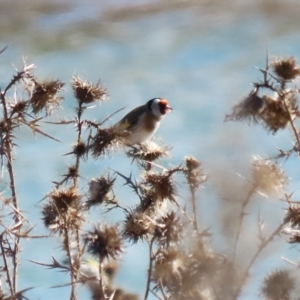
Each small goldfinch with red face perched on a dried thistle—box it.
[115,98,173,146]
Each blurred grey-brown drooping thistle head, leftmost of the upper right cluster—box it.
[225,88,264,122]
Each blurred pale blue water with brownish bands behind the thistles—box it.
[0,0,300,300]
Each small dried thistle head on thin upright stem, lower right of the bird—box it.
[184,156,207,190]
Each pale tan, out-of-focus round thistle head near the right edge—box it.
[252,156,288,195]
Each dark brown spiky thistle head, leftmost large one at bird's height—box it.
[30,80,64,114]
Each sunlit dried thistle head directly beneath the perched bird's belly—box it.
[127,141,170,164]
